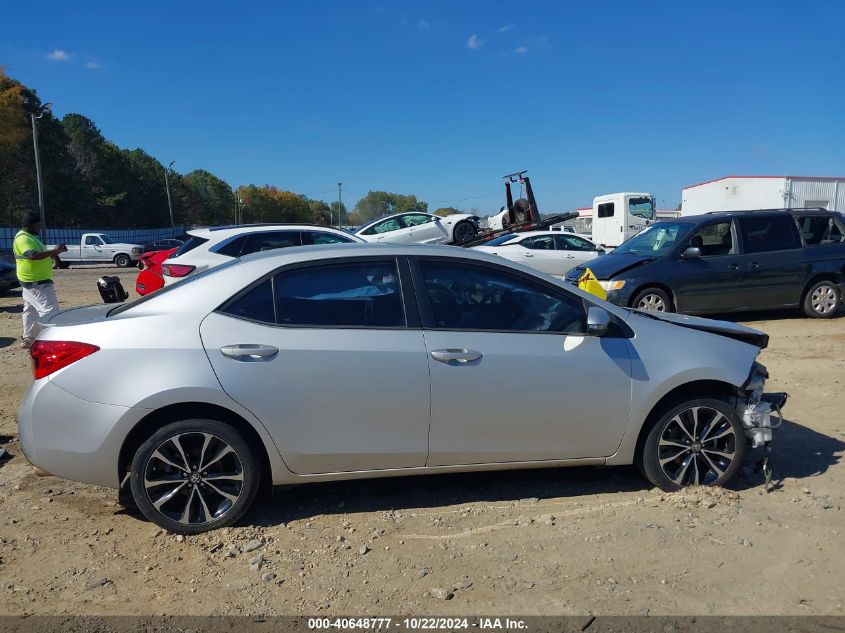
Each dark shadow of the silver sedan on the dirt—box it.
[245,420,845,526]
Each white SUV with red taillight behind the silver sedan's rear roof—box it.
[161,224,364,286]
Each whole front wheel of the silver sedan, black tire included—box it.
[637,398,746,492]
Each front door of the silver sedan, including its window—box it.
[414,258,631,466]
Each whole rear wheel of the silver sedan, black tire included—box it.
[130,420,261,534]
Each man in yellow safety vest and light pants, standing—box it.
[12,212,67,349]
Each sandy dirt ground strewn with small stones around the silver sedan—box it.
[0,268,845,616]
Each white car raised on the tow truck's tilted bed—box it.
[355,212,478,244]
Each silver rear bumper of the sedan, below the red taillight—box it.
[18,379,145,488]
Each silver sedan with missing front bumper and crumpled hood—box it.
[18,244,781,534]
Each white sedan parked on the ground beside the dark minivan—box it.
[474,231,604,277]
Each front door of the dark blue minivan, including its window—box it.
[659,218,747,313]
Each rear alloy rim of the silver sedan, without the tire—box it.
[144,432,244,525]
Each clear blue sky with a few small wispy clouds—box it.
[0,0,845,213]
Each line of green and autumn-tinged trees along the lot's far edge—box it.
[0,67,464,228]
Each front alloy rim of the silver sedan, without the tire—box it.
[657,406,737,486]
